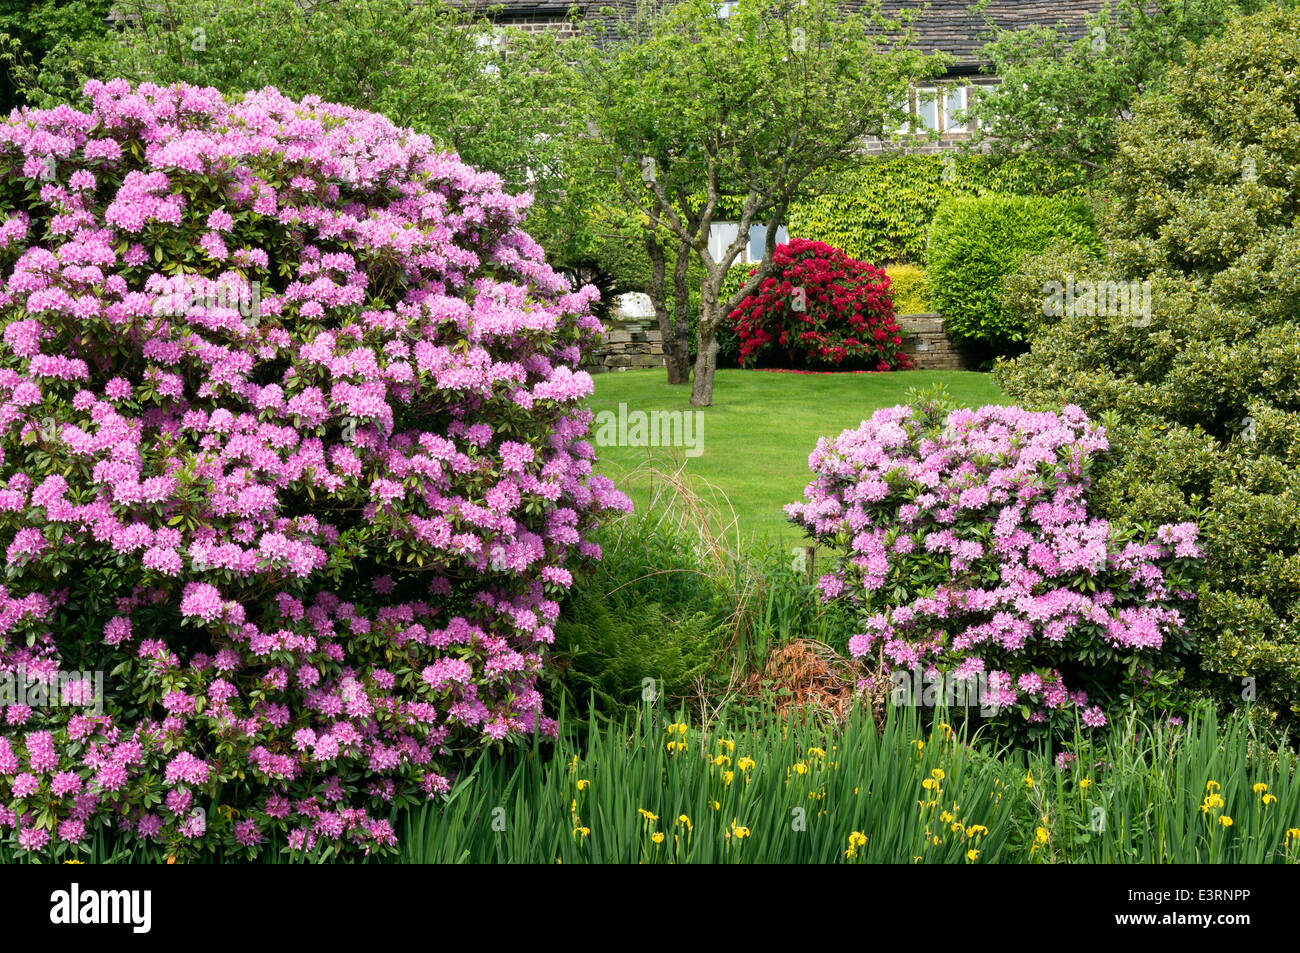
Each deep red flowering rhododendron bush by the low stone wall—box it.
[728,238,913,371]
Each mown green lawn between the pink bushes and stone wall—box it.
[589,369,1008,543]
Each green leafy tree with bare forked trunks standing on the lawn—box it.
[569,0,943,407]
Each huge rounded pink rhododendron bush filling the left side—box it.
[0,81,629,858]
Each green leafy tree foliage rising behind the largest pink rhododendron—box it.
[33,0,579,229]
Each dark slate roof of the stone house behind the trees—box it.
[493,0,1101,73]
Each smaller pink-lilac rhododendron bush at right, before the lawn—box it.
[785,403,1201,736]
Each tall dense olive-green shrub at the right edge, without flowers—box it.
[1000,3,1300,731]
